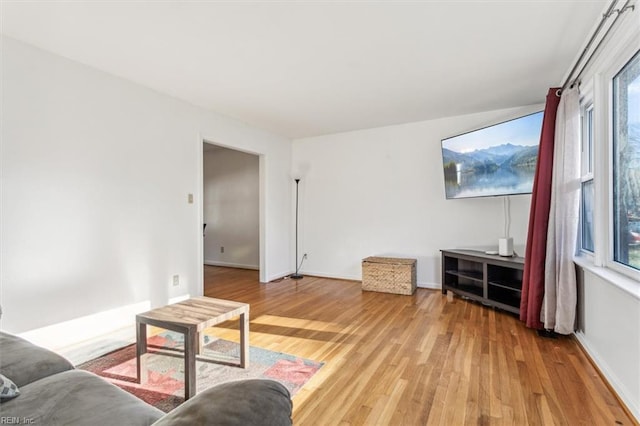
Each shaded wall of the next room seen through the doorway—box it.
[203,148,260,269]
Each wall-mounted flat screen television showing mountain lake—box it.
[442,111,543,199]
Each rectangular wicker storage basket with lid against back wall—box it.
[362,257,416,295]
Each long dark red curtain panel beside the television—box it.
[520,88,560,329]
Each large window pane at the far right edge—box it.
[612,52,640,269]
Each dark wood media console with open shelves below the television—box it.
[441,249,524,314]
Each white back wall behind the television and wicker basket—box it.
[292,105,544,287]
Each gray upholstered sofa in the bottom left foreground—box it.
[0,332,292,426]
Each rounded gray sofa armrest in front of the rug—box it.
[153,379,292,426]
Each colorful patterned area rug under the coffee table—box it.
[78,331,324,412]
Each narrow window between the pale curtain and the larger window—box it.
[580,105,594,253]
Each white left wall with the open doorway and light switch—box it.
[0,38,291,339]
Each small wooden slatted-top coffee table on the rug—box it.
[136,296,249,400]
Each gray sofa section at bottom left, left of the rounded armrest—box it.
[2,370,164,426]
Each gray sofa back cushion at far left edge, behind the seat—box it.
[0,331,73,388]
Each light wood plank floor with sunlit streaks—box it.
[205,266,637,425]
